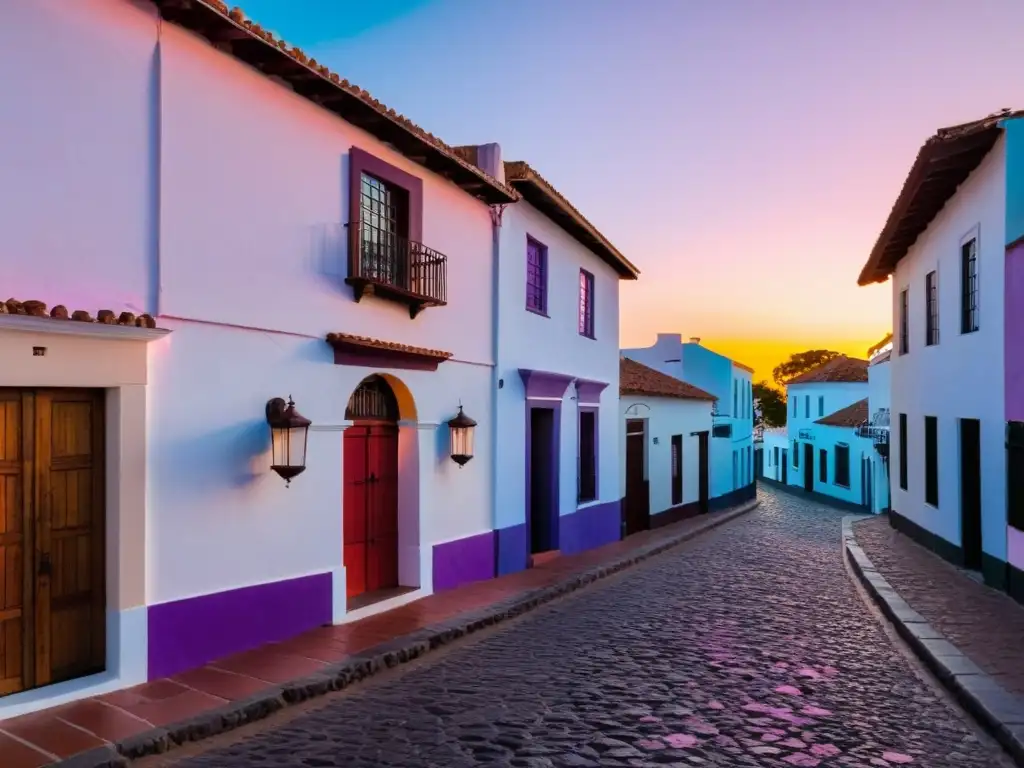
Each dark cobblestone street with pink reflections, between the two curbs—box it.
[163,490,1004,768]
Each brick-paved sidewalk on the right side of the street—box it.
[854,517,1024,694]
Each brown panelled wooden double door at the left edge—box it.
[0,389,106,694]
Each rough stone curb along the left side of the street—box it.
[56,499,761,768]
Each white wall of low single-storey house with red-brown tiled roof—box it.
[620,395,711,516]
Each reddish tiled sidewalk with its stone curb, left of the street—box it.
[0,501,758,768]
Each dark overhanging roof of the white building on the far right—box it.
[857,110,1024,286]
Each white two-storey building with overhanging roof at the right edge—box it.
[859,112,1024,599]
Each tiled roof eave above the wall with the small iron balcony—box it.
[153,0,519,205]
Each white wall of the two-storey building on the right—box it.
[890,138,1007,559]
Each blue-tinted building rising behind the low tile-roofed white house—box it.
[623,334,756,509]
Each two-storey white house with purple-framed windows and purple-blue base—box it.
[452,144,639,573]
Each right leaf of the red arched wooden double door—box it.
[367,424,398,592]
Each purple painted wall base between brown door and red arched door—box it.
[147,573,333,680]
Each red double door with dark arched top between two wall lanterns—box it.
[343,376,398,599]
